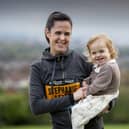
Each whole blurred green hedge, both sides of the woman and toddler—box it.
[0,86,129,125]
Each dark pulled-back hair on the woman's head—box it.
[45,11,72,43]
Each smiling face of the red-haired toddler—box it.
[90,39,111,66]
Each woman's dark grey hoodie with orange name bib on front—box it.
[30,48,104,129]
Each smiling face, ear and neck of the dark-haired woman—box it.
[45,21,72,55]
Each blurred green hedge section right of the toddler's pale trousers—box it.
[104,86,129,123]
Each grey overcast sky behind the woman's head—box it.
[0,0,129,44]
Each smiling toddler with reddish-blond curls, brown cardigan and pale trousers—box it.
[71,34,120,129]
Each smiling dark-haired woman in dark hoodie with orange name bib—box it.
[30,12,111,129]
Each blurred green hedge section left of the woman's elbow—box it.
[0,92,50,125]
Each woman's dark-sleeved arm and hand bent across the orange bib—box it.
[29,64,84,115]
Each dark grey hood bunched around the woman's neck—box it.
[41,47,72,60]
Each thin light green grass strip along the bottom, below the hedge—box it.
[0,124,129,129]
